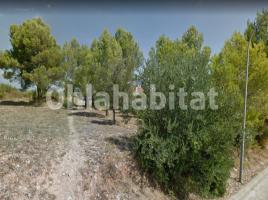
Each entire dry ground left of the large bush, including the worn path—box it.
[0,105,168,200]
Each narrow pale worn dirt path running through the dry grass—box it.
[43,112,85,200]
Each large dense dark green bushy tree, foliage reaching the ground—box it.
[135,27,238,199]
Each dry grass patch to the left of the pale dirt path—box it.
[0,106,68,199]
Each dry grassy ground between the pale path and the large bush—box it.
[67,111,168,200]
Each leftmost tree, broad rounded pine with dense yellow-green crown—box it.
[0,18,63,98]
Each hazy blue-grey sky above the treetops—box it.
[0,4,268,85]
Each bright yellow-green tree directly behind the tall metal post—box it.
[212,33,268,142]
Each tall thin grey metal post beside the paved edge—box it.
[239,31,254,183]
